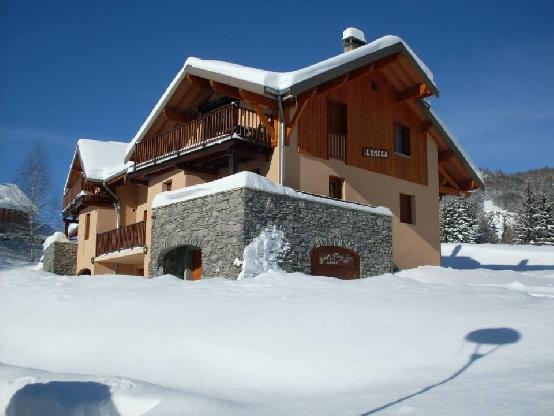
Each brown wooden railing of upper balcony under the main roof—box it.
[134,104,271,165]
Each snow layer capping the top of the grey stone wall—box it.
[152,172,392,215]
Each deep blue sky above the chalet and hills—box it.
[0,0,554,199]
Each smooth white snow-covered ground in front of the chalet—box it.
[0,245,554,416]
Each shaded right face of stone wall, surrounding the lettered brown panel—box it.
[245,189,392,277]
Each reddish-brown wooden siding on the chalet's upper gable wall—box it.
[298,72,427,185]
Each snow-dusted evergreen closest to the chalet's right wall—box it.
[441,197,477,243]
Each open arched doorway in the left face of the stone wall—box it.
[160,245,202,280]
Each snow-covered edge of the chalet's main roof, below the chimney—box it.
[125,35,438,161]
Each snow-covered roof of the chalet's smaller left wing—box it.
[65,139,133,187]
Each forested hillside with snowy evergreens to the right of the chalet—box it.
[441,167,554,245]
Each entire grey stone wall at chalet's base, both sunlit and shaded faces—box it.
[150,188,392,278]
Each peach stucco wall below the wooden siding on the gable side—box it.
[282,128,440,268]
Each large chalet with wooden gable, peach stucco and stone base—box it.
[63,28,483,279]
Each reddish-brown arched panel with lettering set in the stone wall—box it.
[311,246,360,280]
